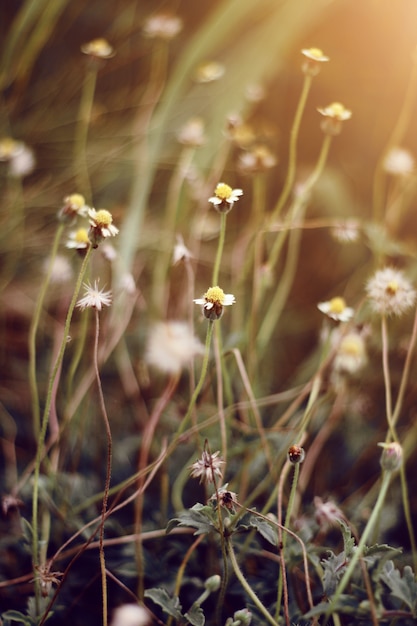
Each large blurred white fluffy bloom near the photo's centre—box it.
[145,321,204,374]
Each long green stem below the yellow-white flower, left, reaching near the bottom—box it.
[32,247,92,604]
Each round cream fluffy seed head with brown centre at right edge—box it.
[366,267,416,316]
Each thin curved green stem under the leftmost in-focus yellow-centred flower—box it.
[28,223,64,438]
